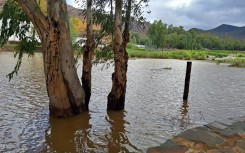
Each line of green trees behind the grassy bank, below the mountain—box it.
[131,20,245,50]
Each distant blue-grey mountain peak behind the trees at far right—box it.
[192,24,245,40]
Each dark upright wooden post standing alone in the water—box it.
[183,61,192,100]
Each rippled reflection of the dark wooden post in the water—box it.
[180,100,190,130]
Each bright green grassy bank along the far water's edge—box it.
[127,48,245,67]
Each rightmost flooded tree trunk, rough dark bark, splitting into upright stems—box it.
[107,0,131,110]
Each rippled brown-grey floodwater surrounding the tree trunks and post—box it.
[0,52,245,153]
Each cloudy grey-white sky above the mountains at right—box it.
[67,0,245,30]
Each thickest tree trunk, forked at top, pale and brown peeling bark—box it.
[17,0,85,117]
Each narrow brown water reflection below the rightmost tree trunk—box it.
[106,111,141,153]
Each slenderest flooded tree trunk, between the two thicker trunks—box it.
[82,0,95,110]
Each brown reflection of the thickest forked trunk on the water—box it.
[44,112,95,153]
